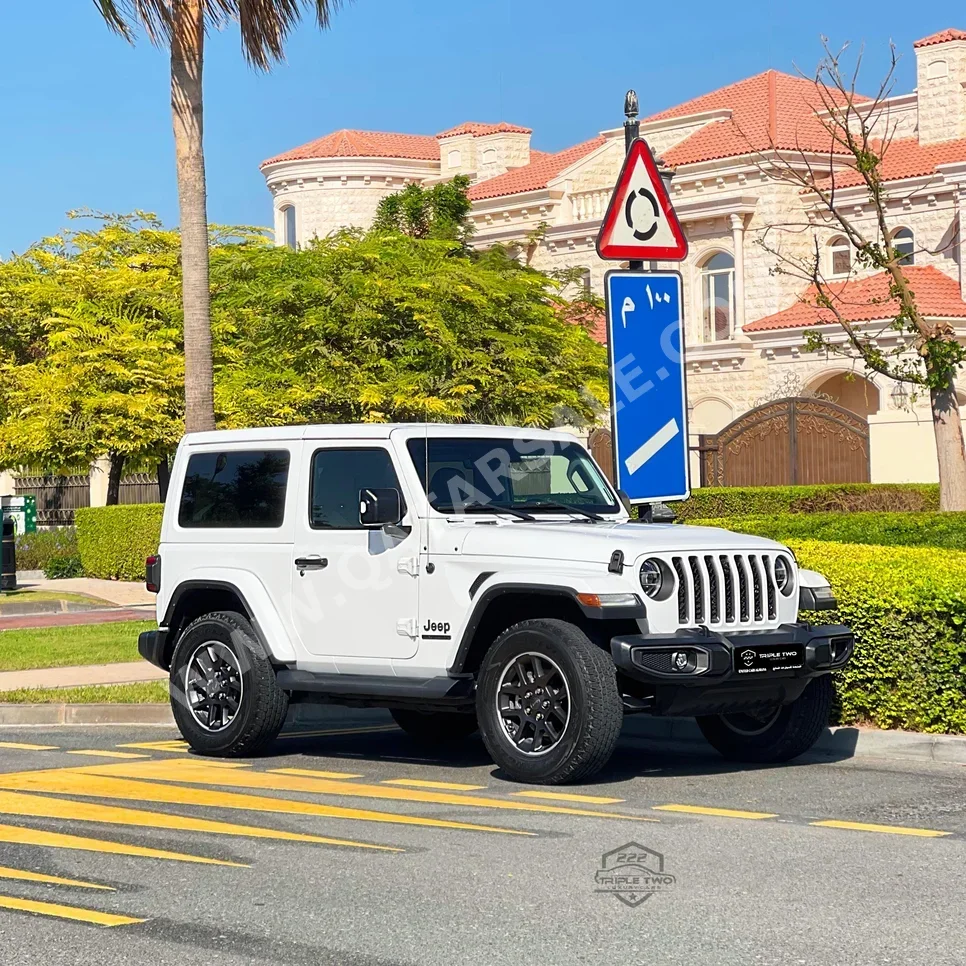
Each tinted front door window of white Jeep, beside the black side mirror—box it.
[309,448,405,530]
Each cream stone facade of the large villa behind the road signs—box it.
[263,31,966,480]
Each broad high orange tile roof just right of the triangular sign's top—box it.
[647,70,866,167]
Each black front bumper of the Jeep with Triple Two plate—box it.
[610,623,855,715]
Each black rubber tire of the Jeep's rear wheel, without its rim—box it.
[170,611,288,758]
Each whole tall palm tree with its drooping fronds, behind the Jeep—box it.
[94,0,341,433]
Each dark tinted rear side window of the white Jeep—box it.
[178,450,289,529]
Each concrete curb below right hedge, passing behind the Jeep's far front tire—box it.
[629,715,966,765]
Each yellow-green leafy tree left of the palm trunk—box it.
[0,211,184,502]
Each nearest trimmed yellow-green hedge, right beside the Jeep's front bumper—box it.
[790,540,966,734]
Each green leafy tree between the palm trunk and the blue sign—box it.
[212,229,607,426]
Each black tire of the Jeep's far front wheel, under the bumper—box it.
[697,674,832,764]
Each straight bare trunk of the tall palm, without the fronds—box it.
[171,0,215,433]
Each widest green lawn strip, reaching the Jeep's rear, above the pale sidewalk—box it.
[0,621,157,671]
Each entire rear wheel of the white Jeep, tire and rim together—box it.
[170,611,288,758]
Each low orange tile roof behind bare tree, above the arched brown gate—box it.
[744,265,966,332]
